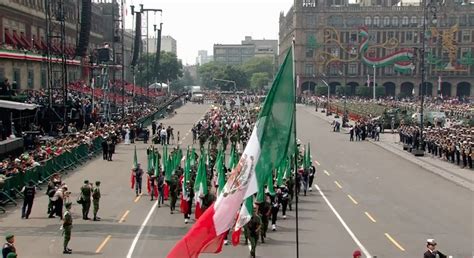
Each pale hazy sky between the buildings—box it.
[126,0,293,64]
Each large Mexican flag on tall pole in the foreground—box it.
[168,47,295,258]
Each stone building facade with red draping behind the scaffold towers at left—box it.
[0,0,108,90]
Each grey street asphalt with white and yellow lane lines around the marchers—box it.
[0,104,474,258]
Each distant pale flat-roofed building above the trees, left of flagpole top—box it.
[214,36,278,65]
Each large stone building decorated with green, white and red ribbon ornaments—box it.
[279,0,474,96]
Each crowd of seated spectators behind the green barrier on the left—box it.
[0,88,178,176]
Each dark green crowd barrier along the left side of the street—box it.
[0,137,103,211]
